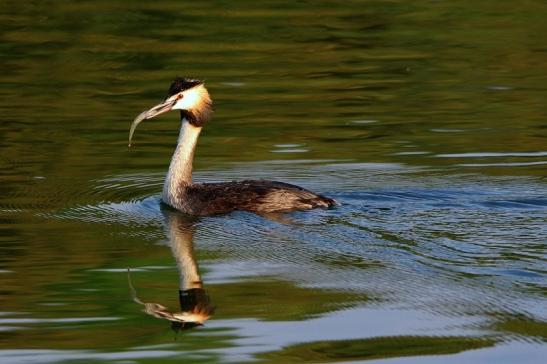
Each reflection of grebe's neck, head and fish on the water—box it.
[127,207,215,332]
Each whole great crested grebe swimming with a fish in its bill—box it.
[129,77,336,215]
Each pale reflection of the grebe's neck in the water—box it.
[169,218,202,291]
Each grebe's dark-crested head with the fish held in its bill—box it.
[129,77,213,146]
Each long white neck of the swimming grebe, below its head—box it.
[162,119,201,207]
